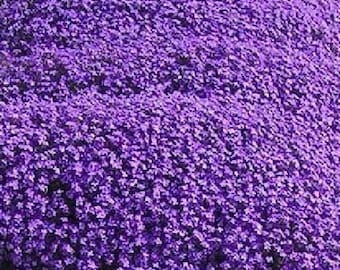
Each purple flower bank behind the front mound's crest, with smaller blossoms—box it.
[0,0,340,105]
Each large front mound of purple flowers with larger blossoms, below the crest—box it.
[0,94,339,269]
